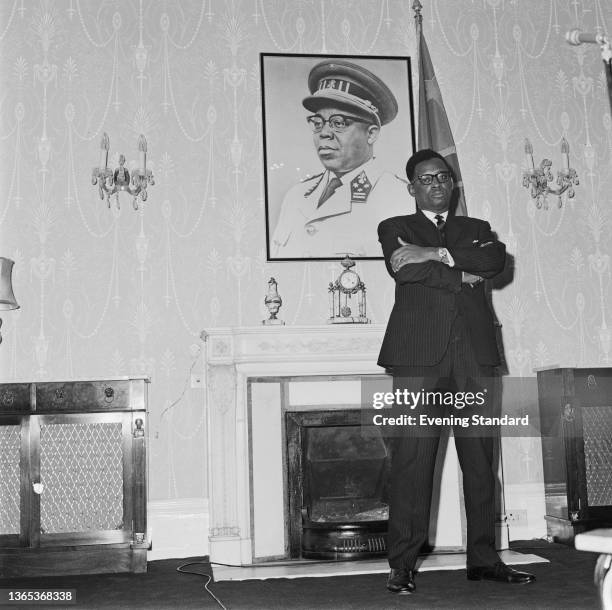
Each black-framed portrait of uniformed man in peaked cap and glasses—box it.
[260,53,416,261]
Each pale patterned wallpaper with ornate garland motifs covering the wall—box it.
[0,0,612,498]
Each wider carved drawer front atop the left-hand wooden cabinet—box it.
[36,380,130,413]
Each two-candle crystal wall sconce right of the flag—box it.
[523,138,580,210]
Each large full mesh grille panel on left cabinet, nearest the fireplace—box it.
[40,423,123,534]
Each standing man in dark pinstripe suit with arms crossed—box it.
[378,149,534,594]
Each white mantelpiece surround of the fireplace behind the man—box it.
[206,325,463,565]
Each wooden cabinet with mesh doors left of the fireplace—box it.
[0,378,149,578]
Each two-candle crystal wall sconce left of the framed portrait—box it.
[91,132,155,210]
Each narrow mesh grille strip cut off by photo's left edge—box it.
[0,426,21,534]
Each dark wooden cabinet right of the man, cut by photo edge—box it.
[538,368,612,543]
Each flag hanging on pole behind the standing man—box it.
[413,0,467,216]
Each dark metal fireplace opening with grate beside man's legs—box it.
[286,409,390,560]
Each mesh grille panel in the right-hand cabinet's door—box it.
[582,407,612,506]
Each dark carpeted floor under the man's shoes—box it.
[0,540,598,610]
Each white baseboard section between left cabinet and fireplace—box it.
[147,498,209,561]
